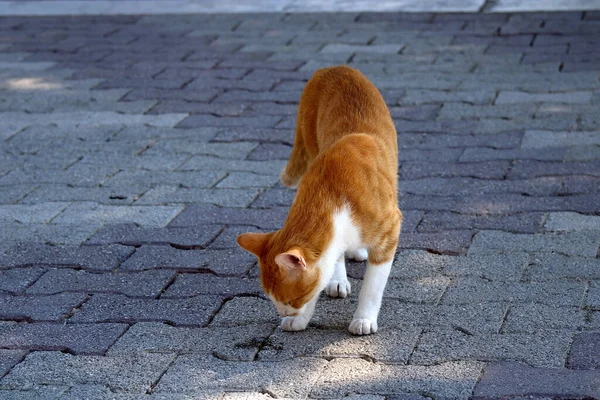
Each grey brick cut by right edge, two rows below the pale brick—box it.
[525,253,600,281]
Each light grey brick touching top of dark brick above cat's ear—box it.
[136,185,259,208]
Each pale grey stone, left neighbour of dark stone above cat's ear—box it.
[53,203,183,226]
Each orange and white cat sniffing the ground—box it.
[238,66,402,335]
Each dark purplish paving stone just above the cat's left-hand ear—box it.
[169,204,289,229]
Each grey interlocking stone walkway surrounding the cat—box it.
[0,7,600,400]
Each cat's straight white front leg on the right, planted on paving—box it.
[348,259,393,335]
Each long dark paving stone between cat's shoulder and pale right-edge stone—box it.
[418,211,545,233]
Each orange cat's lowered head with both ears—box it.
[237,232,321,316]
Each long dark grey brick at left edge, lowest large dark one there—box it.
[0,322,127,355]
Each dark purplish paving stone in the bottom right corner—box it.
[474,362,600,399]
